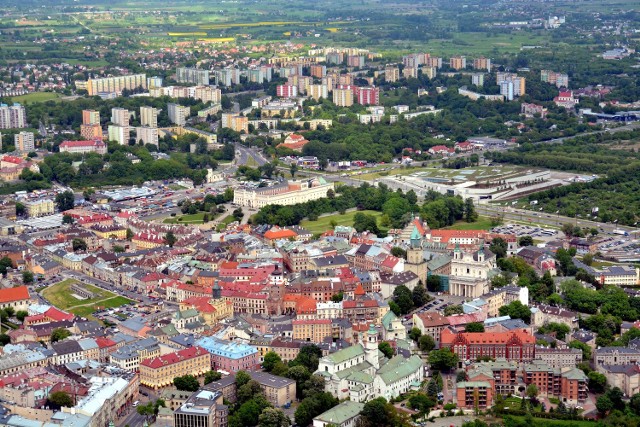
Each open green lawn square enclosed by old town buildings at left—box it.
[42,279,131,318]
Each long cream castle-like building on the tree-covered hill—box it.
[233,177,334,209]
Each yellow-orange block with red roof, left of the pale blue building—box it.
[140,346,211,390]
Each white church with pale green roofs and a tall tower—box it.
[315,325,424,402]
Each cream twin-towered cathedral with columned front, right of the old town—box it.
[449,244,497,298]
